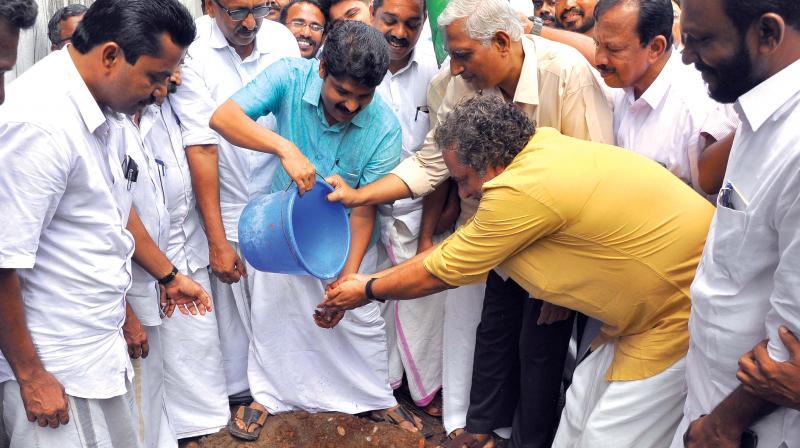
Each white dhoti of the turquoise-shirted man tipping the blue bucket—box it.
[248,248,396,414]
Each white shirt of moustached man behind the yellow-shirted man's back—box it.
[614,51,739,188]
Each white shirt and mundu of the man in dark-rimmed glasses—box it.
[170,18,300,395]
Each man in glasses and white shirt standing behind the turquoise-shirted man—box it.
[170,0,306,402]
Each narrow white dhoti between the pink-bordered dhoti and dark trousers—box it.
[442,283,486,434]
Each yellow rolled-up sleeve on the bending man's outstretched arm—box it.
[424,186,564,286]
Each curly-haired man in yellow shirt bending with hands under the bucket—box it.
[322,95,714,448]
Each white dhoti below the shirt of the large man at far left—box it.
[0,381,142,448]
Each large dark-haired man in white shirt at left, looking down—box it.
[0,0,210,448]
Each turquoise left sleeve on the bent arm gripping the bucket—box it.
[231,58,290,120]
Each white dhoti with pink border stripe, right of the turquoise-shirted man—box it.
[378,205,447,406]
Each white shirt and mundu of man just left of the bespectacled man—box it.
[140,101,230,439]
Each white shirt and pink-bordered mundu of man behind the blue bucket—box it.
[377,42,447,406]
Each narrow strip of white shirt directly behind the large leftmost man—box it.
[126,114,170,327]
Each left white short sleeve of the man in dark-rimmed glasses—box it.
[169,49,219,147]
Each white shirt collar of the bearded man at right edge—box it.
[735,60,800,132]
